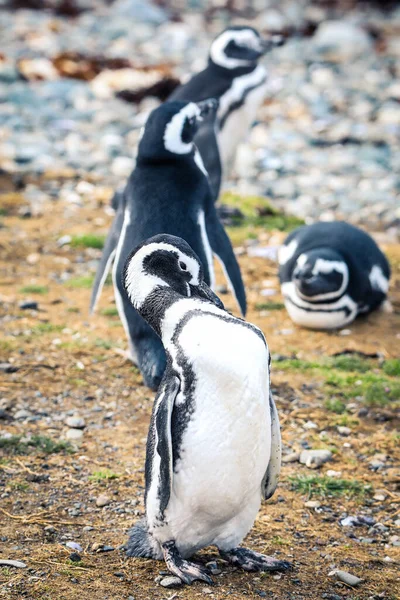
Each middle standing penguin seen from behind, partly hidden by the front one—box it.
[91,100,246,389]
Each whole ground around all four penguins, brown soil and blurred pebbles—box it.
[0,0,400,600]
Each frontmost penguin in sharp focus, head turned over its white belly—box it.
[123,235,290,584]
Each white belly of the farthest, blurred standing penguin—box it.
[218,83,268,167]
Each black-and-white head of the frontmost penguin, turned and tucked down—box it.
[123,234,224,312]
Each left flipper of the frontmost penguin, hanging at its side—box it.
[146,372,180,527]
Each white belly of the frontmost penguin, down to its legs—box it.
[166,314,271,556]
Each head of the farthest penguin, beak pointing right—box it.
[210,26,283,70]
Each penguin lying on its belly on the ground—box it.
[278,221,390,329]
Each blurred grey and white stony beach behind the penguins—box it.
[0,0,400,232]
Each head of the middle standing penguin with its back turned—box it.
[138,98,218,162]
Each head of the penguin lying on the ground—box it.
[292,248,349,302]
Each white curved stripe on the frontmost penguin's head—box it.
[125,242,200,308]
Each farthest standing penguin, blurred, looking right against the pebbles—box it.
[169,25,283,200]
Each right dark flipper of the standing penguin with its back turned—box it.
[206,206,247,317]
